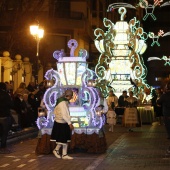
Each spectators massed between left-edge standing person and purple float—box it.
[5,82,46,131]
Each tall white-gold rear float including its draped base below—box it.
[94,3,157,126]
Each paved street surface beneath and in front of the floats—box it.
[0,123,170,170]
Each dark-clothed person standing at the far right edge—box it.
[157,81,170,154]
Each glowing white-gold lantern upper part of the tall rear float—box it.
[94,4,150,96]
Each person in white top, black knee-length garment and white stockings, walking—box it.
[51,90,74,159]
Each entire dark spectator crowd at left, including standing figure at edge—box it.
[0,82,46,154]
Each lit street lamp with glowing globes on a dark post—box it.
[30,24,44,84]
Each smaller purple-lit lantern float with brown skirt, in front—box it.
[37,39,106,153]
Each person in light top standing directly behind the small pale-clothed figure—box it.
[107,90,118,110]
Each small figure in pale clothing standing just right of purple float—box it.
[106,110,116,132]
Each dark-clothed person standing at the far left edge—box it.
[0,82,13,154]
